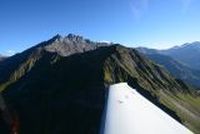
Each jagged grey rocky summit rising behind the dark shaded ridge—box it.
[33,33,110,56]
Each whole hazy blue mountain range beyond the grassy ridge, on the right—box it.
[137,42,200,88]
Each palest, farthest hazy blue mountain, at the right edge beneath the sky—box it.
[160,42,200,70]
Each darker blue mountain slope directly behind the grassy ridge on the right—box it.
[137,46,200,88]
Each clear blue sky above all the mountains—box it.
[0,0,200,55]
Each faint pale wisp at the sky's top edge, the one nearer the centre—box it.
[131,0,150,19]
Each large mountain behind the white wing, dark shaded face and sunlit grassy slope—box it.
[0,35,200,134]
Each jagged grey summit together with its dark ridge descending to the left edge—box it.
[0,34,110,83]
